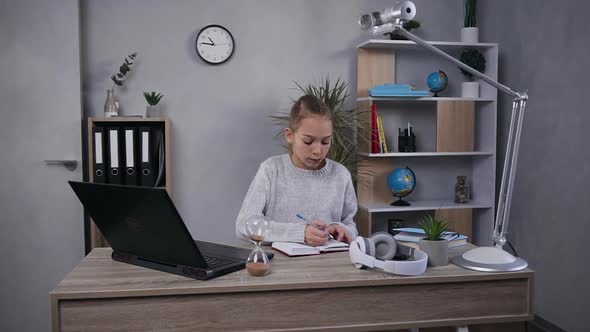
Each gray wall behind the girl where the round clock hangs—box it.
[82,0,462,243]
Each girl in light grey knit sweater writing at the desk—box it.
[236,95,358,246]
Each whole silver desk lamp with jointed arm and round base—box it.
[358,1,528,272]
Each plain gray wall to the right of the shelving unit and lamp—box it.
[479,0,590,331]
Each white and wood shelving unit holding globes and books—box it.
[357,39,498,245]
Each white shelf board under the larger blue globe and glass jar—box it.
[359,197,492,213]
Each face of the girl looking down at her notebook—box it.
[285,114,332,170]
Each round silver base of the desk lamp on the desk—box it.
[451,247,528,272]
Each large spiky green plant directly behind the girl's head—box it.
[271,76,370,178]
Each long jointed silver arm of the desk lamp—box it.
[394,24,528,249]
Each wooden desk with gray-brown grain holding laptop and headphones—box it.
[51,245,534,331]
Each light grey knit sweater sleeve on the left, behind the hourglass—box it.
[236,163,305,243]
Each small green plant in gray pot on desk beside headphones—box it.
[418,215,449,266]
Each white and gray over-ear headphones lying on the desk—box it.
[348,232,428,276]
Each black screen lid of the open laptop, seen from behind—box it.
[69,181,206,267]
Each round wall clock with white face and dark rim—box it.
[195,25,235,65]
